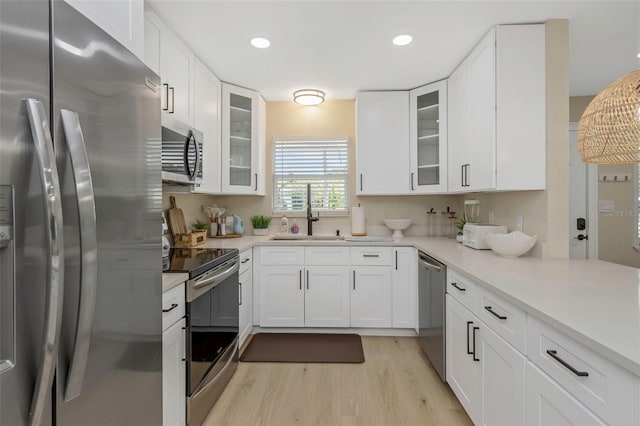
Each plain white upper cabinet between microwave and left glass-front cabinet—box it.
[194,60,222,194]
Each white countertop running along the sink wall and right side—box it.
[163,236,640,376]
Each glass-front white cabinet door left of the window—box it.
[222,83,259,194]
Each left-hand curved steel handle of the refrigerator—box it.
[26,98,64,425]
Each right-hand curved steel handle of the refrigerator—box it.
[60,109,98,401]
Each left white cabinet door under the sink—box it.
[259,266,304,327]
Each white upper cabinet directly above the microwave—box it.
[144,12,196,126]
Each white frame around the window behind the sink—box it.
[271,135,351,217]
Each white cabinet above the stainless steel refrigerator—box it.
[65,0,145,59]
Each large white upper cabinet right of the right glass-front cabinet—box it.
[448,24,546,192]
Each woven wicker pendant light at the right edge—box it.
[578,70,640,164]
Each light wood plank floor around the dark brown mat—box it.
[204,336,472,426]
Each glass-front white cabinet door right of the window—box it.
[409,80,447,194]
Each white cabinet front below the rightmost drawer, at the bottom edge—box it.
[526,362,606,426]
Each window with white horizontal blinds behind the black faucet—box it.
[273,138,349,216]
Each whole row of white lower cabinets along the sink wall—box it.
[253,245,418,329]
